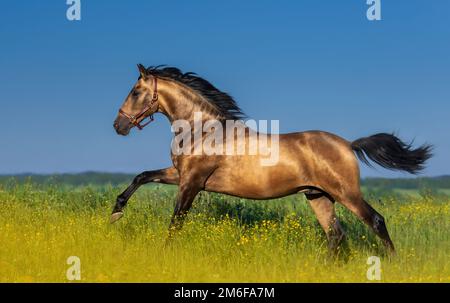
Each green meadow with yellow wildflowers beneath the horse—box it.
[0,178,450,282]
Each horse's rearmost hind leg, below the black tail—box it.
[340,197,395,253]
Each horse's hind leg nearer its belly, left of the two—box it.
[306,193,345,255]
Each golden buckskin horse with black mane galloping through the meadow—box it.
[111,64,431,252]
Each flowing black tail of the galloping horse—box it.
[352,134,432,174]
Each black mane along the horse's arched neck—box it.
[147,66,245,120]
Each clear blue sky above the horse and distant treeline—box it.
[0,0,450,177]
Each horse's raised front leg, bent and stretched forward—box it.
[110,167,179,223]
